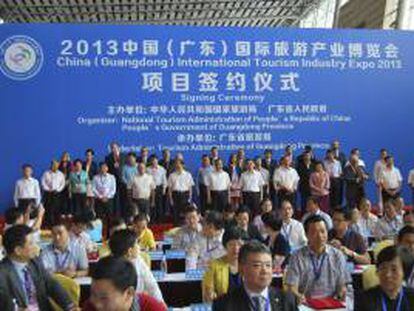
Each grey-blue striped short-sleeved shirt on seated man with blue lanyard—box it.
[286,245,351,297]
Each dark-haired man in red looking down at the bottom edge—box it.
[82,256,167,311]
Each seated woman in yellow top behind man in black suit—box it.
[202,227,246,303]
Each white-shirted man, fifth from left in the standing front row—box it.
[129,162,155,215]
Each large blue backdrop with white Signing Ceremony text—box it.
[0,24,414,214]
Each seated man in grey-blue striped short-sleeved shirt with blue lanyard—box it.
[286,215,350,303]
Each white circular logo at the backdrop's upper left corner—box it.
[0,36,43,80]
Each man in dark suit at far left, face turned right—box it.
[0,225,80,311]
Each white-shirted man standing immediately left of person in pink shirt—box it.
[273,156,299,211]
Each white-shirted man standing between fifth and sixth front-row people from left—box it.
[147,155,167,221]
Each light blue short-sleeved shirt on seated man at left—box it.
[41,240,89,273]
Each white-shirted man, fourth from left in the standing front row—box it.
[92,162,116,228]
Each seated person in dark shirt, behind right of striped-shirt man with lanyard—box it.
[328,208,371,265]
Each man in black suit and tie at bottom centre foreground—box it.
[213,241,298,311]
